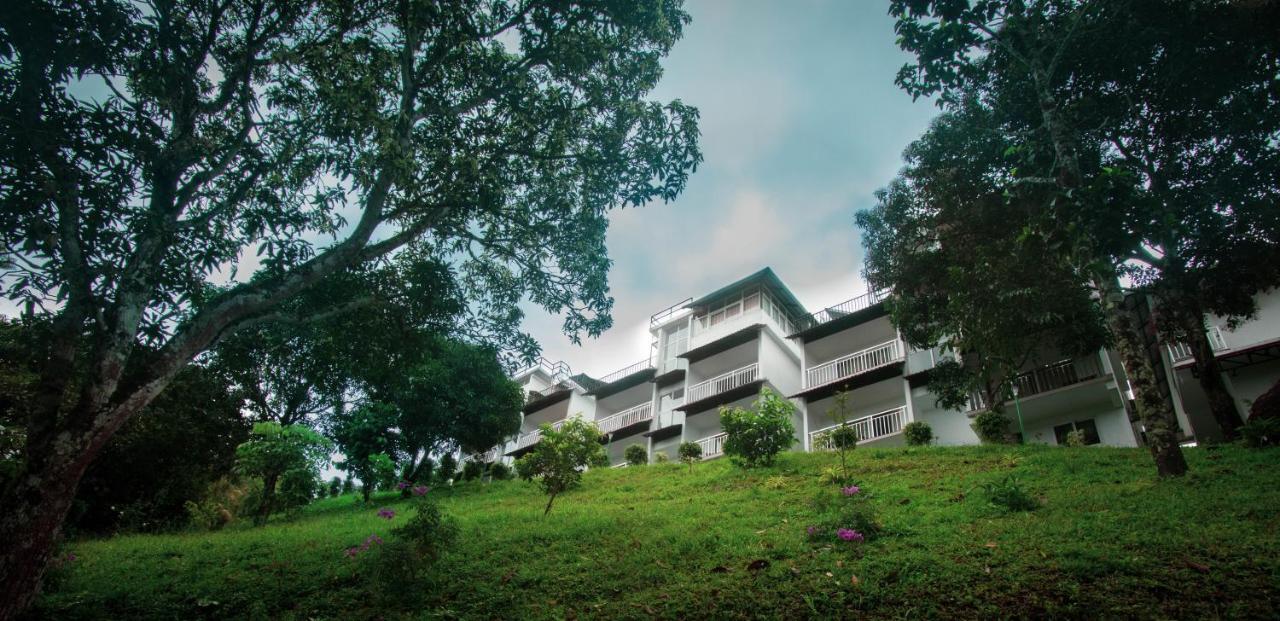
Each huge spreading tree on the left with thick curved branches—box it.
[0,0,701,609]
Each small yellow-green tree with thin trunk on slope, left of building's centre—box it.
[516,416,607,515]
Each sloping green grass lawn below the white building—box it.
[36,447,1280,618]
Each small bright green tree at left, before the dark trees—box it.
[236,423,330,525]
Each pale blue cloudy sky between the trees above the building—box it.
[525,0,937,376]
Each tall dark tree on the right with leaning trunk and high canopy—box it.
[891,0,1280,476]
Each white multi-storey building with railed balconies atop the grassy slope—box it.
[483,268,1280,466]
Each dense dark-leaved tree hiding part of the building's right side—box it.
[856,99,1107,432]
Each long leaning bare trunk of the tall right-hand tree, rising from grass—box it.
[1097,275,1187,476]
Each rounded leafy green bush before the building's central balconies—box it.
[721,388,796,467]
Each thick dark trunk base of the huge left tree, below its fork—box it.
[0,434,96,621]
